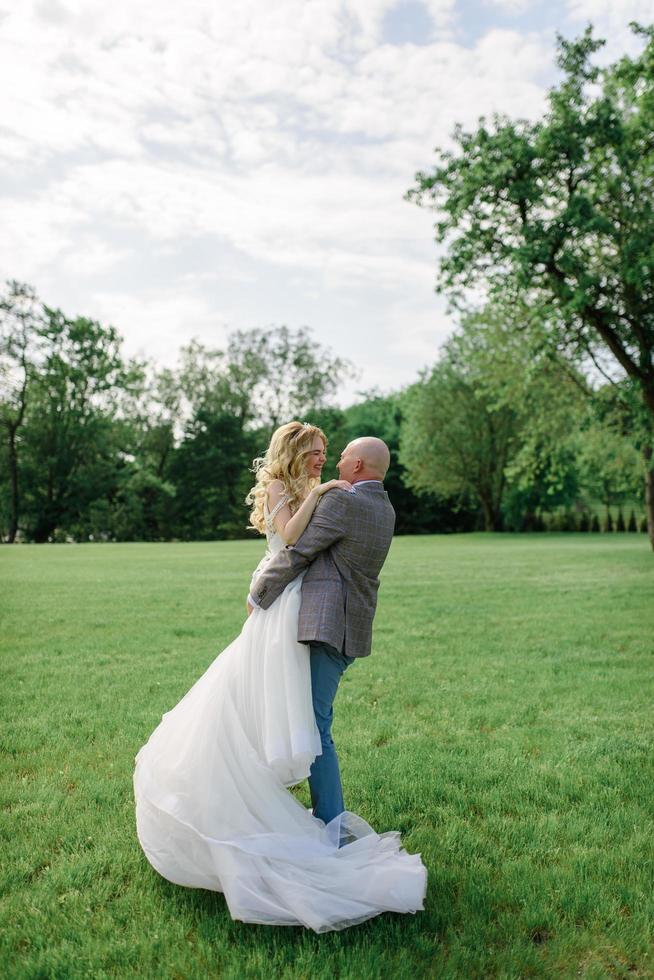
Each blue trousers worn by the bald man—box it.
[309,643,355,823]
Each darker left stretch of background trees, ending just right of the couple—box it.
[0,294,470,542]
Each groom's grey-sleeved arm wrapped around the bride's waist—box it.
[251,489,351,609]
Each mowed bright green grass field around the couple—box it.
[0,534,654,980]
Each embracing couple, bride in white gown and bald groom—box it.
[134,422,427,932]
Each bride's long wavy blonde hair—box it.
[245,422,327,534]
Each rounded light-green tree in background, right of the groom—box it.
[400,303,587,530]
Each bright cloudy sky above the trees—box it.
[0,0,654,401]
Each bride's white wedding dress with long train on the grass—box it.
[134,502,427,932]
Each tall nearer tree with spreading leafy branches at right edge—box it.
[407,24,654,548]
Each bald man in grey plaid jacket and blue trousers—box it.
[249,436,395,823]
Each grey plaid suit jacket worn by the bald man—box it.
[252,483,395,657]
